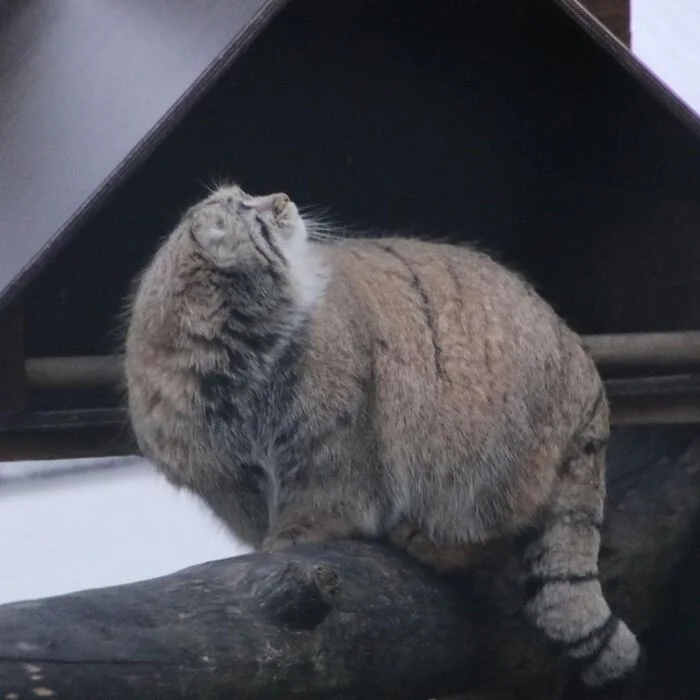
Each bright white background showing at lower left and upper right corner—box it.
[0,0,700,603]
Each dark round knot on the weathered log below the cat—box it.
[254,562,340,630]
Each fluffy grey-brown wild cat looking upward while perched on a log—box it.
[126,186,640,688]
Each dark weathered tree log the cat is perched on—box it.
[0,427,700,700]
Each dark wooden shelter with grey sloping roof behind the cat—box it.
[0,0,700,459]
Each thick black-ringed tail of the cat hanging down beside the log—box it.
[523,383,640,691]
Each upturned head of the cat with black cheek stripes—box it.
[185,185,307,269]
